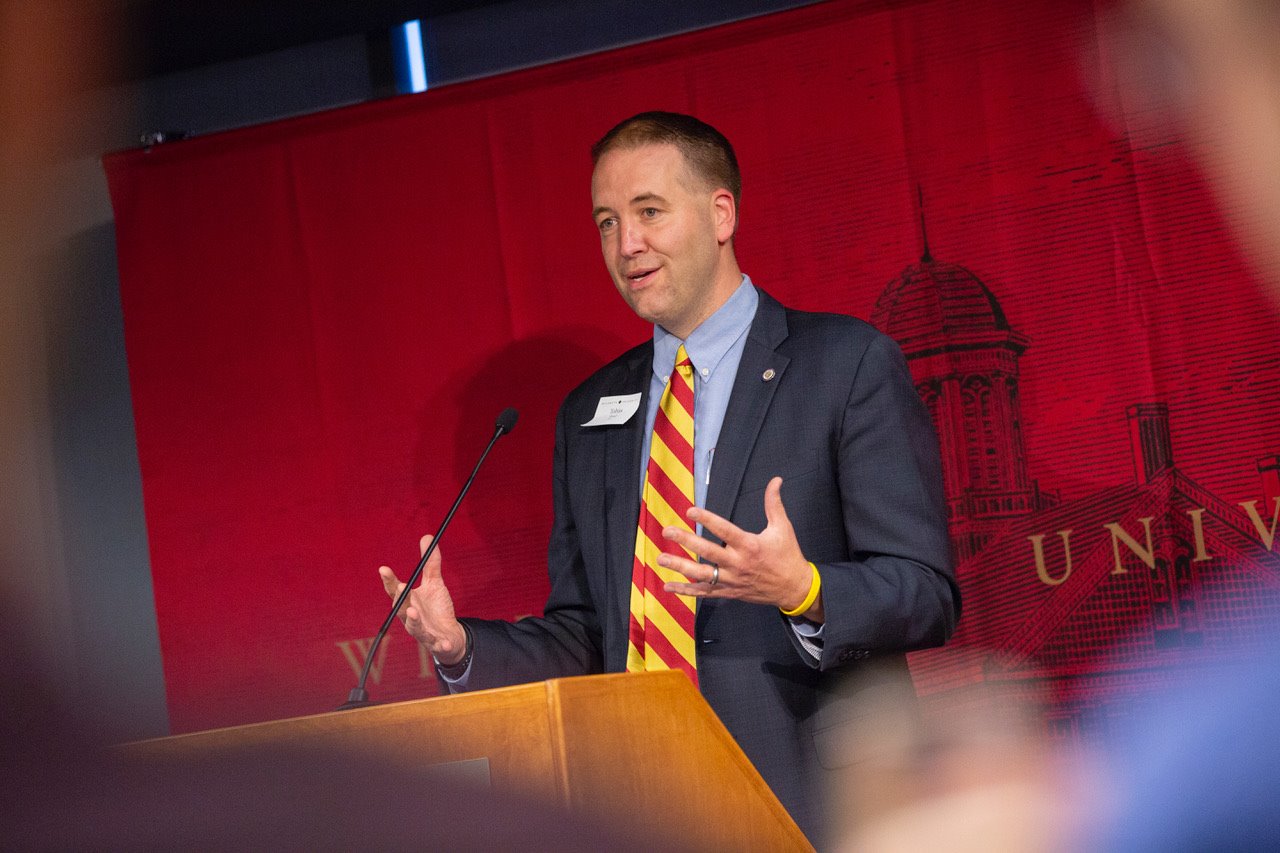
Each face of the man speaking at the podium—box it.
[591,145,737,338]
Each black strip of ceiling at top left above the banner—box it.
[120,0,509,79]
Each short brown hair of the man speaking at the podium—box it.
[591,111,742,207]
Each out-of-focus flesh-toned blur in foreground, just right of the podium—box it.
[831,666,1091,853]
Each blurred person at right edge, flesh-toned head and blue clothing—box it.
[1089,0,1280,853]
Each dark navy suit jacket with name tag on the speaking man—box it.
[463,286,959,841]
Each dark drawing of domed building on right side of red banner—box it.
[870,219,1280,742]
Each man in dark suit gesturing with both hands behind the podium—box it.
[381,113,959,839]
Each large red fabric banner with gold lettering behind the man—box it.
[106,0,1280,733]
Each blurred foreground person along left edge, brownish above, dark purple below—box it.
[0,0,667,852]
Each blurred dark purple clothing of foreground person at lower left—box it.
[0,607,681,853]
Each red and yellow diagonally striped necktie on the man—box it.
[627,345,698,686]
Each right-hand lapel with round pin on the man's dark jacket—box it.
[707,291,790,519]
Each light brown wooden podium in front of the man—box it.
[127,671,813,850]
